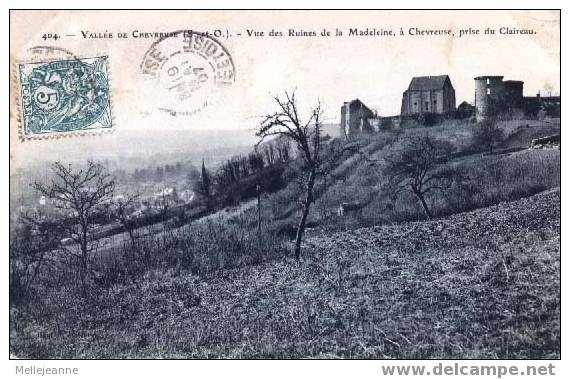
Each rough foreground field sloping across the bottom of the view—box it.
[10,189,560,359]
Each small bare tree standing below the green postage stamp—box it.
[33,161,115,294]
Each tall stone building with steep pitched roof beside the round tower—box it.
[400,75,455,116]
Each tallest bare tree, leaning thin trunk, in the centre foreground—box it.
[256,91,351,260]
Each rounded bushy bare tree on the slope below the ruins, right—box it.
[385,134,455,219]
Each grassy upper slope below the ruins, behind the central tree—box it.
[258,120,560,232]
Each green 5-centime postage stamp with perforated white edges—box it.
[17,55,113,139]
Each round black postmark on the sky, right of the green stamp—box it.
[140,30,235,116]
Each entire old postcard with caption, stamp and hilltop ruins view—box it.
[7,10,561,364]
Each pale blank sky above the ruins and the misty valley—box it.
[10,11,560,166]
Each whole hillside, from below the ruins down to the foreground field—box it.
[10,120,561,359]
